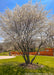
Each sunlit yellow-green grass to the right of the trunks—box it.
[31,56,54,68]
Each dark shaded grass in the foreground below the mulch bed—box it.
[0,62,54,75]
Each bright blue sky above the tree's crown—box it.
[0,0,54,41]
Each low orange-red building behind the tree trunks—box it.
[10,48,54,56]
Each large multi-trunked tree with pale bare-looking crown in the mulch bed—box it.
[0,2,53,64]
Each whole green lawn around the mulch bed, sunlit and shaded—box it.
[0,55,54,75]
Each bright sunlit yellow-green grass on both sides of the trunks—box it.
[0,55,54,68]
